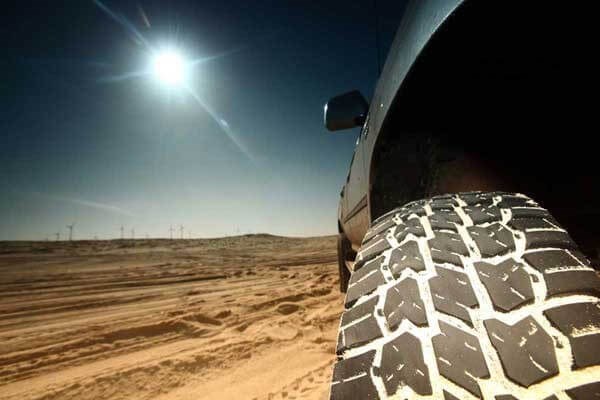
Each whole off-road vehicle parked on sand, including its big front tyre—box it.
[325,0,600,400]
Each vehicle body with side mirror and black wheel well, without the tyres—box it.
[325,0,600,268]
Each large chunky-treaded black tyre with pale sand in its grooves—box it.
[330,192,600,400]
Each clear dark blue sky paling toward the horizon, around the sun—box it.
[0,0,403,240]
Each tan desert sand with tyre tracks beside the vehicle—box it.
[0,235,342,400]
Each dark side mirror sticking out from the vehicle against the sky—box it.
[325,90,369,131]
